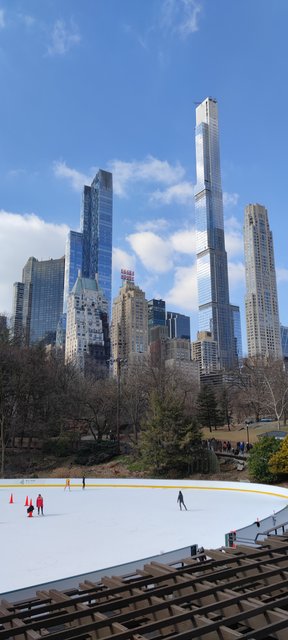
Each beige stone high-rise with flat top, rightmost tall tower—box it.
[244,204,282,359]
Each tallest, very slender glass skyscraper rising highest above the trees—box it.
[195,98,236,369]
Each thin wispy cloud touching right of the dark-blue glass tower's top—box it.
[109,155,185,197]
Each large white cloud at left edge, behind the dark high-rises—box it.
[0,210,68,313]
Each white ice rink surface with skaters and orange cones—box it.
[0,478,288,593]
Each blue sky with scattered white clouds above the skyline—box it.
[0,0,288,349]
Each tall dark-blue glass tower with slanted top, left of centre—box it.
[81,169,113,315]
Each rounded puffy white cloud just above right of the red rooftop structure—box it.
[126,231,173,273]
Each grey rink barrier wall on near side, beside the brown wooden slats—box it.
[0,544,198,602]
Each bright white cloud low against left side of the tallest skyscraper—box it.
[165,264,198,313]
